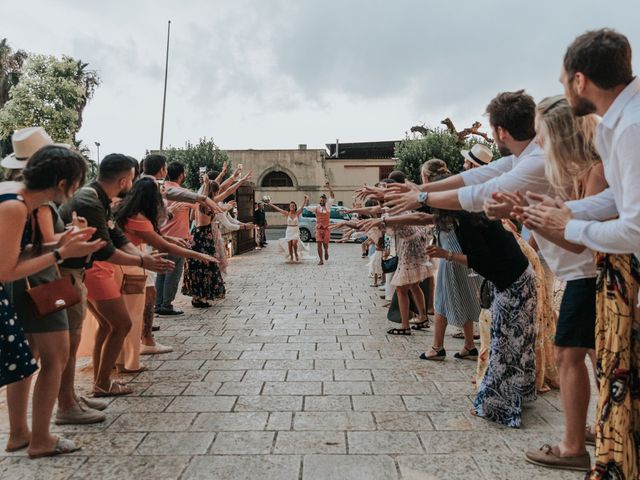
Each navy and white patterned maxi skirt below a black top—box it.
[473,268,536,428]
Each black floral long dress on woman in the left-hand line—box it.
[182,225,225,300]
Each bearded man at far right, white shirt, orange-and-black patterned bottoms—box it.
[523,29,640,480]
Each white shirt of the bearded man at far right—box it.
[564,78,640,258]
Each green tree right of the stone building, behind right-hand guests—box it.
[395,128,500,183]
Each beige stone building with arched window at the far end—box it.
[227,141,397,225]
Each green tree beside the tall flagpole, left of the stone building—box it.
[162,137,229,190]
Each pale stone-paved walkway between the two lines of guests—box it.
[0,242,593,480]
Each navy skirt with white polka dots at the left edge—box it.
[0,284,38,386]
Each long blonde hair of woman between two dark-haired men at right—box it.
[536,95,600,200]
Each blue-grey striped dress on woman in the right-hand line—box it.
[434,230,483,328]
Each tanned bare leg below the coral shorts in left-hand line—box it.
[89,297,131,390]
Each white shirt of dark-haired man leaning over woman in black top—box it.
[458,141,596,281]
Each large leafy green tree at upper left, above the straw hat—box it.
[0,55,100,144]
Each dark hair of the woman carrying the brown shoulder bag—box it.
[22,145,87,196]
